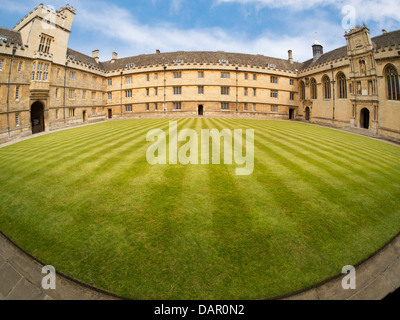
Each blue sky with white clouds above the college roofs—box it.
[0,0,400,62]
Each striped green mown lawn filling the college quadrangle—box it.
[0,119,400,299]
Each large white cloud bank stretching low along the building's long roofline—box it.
[60,1,344,61]
